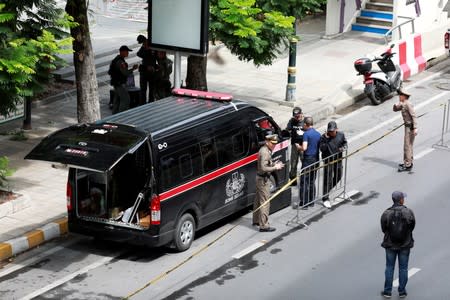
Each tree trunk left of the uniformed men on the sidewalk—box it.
[66,0,101,123]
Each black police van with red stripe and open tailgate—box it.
[25,89,291,251]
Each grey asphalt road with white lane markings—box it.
[0,62,450,300]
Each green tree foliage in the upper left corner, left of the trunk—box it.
[0,0,71,115]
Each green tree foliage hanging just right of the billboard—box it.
[209,0,295,66]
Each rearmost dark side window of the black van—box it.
[161,144,202,190]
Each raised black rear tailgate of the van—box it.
[25,123,147,172]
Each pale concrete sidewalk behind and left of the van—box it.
[0,12,440,260]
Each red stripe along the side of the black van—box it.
[159,140,289,201]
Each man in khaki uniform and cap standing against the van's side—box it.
[253,134,284,232]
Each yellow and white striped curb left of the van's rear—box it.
[0,218,68,261]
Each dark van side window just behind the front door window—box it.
[216,127,250,166]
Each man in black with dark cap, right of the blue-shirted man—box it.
[319,121,347,208]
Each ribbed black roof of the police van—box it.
[97,96,250,139]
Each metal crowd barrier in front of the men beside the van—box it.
[288,149,349,227]
